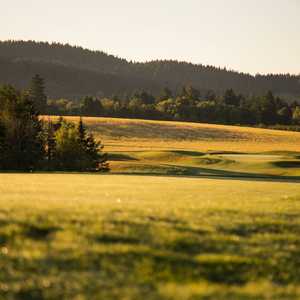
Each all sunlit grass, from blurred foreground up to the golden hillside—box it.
[0,117,300,300]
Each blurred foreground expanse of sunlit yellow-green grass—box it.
[0,174,300,300]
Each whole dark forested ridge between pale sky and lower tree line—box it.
[0,41,300,99]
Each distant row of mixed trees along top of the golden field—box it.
[45,86,300,126]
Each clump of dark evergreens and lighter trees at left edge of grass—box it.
[0,76,109,171]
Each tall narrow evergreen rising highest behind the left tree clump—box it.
[28,74,47,114]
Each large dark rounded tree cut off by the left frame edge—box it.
[0,86,44,170]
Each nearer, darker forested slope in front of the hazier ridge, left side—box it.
[0,56,160,99]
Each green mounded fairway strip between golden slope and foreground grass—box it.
[108,150,300,178]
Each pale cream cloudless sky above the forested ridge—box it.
[0,0,300,74]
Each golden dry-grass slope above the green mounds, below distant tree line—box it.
[49,117,300,152]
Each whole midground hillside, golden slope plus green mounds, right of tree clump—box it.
[44,117,300,180]
